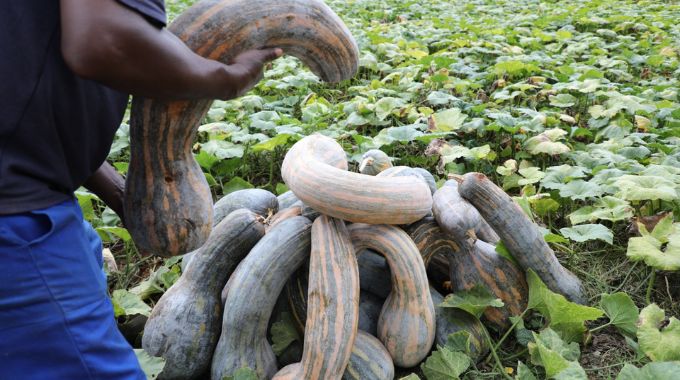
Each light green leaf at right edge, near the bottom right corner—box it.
[637,304,680,362]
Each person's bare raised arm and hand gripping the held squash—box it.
[60,0,282,99]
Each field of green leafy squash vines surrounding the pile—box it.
[85,0,680,380]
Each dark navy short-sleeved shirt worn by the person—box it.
[0,0,166,214]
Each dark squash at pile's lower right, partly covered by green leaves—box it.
[430,287,490,362]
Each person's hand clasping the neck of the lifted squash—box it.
[225,48,283,100]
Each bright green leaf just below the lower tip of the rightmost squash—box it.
[527,269,603,342]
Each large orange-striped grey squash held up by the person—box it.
[125,0,358,256]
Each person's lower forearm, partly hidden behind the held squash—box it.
[83,161,125,225]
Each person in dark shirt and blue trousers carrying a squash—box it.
[0,0,282,380]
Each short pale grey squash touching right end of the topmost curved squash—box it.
[432,180,500,244]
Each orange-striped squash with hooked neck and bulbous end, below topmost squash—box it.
[349,224,435,367]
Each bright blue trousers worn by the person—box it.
[0,199,146,380]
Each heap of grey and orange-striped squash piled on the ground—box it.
[142,135,583,380]
